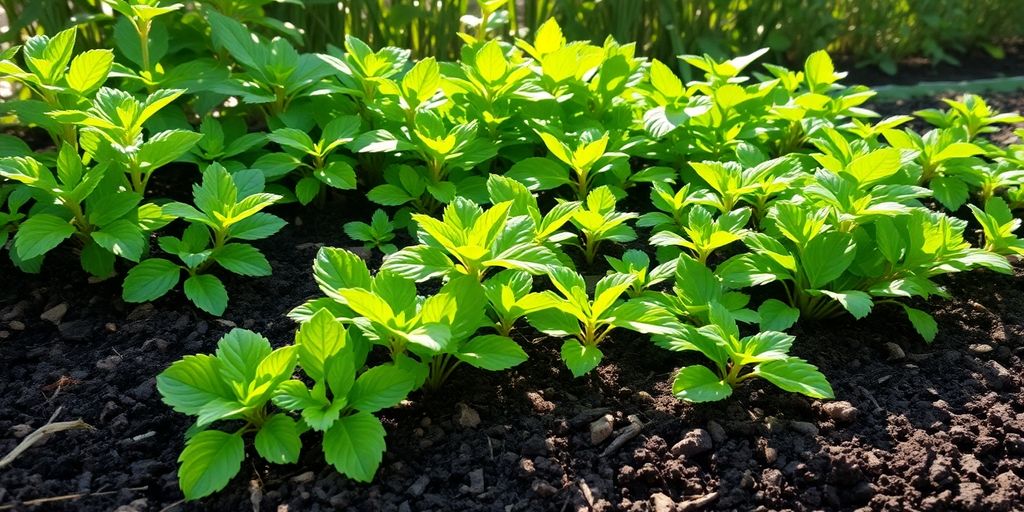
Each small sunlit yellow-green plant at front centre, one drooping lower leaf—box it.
[524,267,677,377]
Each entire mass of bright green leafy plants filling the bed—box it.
[0,6,1024,499]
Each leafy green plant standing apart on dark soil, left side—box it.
[122,164,285,315]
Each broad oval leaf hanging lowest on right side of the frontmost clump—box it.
[324,413,386,482]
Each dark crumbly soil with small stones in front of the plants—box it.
[0,95,1024,512]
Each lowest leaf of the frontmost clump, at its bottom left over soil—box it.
[178,430,246,500]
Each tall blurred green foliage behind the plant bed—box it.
[0,0,1024,73]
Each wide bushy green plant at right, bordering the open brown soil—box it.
[717,203,1012,341]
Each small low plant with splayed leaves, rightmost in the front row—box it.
[662,302,835,402]
